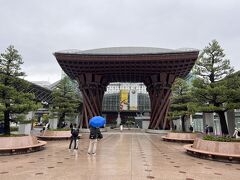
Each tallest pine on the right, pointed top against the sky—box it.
[192,40,233,134]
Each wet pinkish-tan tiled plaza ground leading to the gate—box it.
[0,131,240,180]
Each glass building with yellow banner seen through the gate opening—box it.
[102,83,150,123]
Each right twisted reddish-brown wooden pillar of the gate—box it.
[144,73,175,129]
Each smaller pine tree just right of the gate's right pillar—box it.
[169,78,192,131]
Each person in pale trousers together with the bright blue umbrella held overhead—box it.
[88,116,106,155]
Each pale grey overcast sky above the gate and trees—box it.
[0,0,240,82]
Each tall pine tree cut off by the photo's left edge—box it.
[0,46,36,134]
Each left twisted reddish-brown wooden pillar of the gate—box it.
[77,73,107,128]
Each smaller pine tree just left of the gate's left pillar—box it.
[51,76,80,128]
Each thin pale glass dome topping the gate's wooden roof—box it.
[56,47,198,55]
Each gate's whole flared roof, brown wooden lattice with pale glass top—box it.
[54,47,199,82]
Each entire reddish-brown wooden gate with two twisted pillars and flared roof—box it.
[54,47,199,129]
